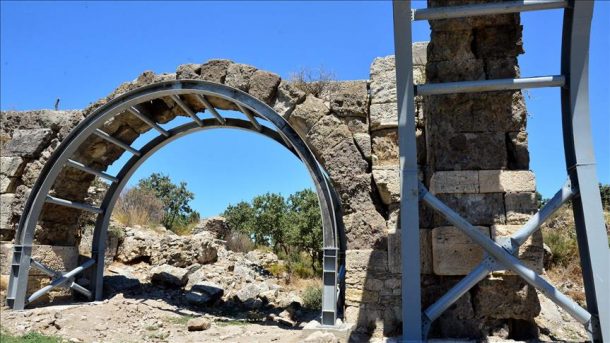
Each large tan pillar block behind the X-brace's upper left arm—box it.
[432,226,491,275]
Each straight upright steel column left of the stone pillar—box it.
[393,0,422,342]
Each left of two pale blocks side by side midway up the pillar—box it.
[430,170,479,194]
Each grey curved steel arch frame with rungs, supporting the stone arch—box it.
[7,80,346,326]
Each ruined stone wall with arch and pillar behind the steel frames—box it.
[0,6,543,337]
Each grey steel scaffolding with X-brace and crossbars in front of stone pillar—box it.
[393,0,610,342]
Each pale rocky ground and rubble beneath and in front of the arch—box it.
[1,221,587,343]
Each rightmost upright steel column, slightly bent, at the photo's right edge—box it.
[561,0,610,342]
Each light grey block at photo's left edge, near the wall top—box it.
[2,129,53,157]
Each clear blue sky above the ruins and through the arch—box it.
[0,1,610,216]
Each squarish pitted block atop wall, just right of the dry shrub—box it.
[329,80,369,117]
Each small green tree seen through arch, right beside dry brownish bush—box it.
[138,173,199,231]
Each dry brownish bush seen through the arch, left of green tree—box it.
[113,187,164,226]
